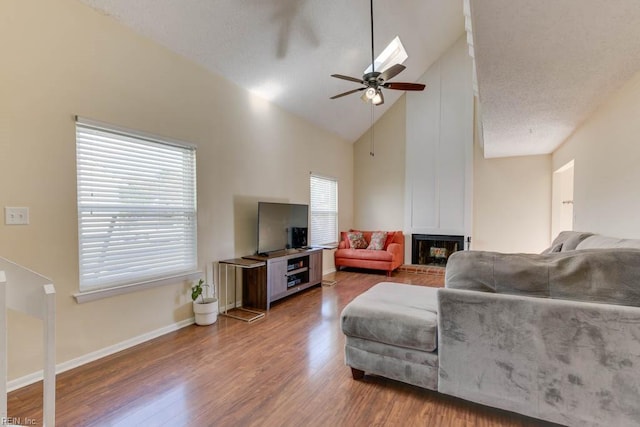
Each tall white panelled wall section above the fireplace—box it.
[404,37,473,241]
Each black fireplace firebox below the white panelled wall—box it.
[411,234,464,266]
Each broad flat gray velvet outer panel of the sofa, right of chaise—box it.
[438,288,640,425]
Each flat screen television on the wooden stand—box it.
[258,202,309,255]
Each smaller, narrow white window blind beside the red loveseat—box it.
[310,175,338,245]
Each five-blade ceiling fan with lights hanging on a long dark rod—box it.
[330,0,425,105]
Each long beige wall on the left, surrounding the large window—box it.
[0,0,352,379]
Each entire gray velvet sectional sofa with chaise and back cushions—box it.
[342,232,640,426]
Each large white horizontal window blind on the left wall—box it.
[76,119,197,292]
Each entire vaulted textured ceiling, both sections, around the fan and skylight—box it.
[81,0,640,157]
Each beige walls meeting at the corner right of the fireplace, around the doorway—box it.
[472,40,640,252]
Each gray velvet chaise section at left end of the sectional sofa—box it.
[342,282,438,390]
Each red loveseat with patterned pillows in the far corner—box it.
[334,230,404,276]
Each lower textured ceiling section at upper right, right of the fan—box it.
[471,0,640,157]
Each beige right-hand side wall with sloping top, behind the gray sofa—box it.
[553,68,640,238]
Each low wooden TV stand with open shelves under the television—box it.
[242,249,322,310]
